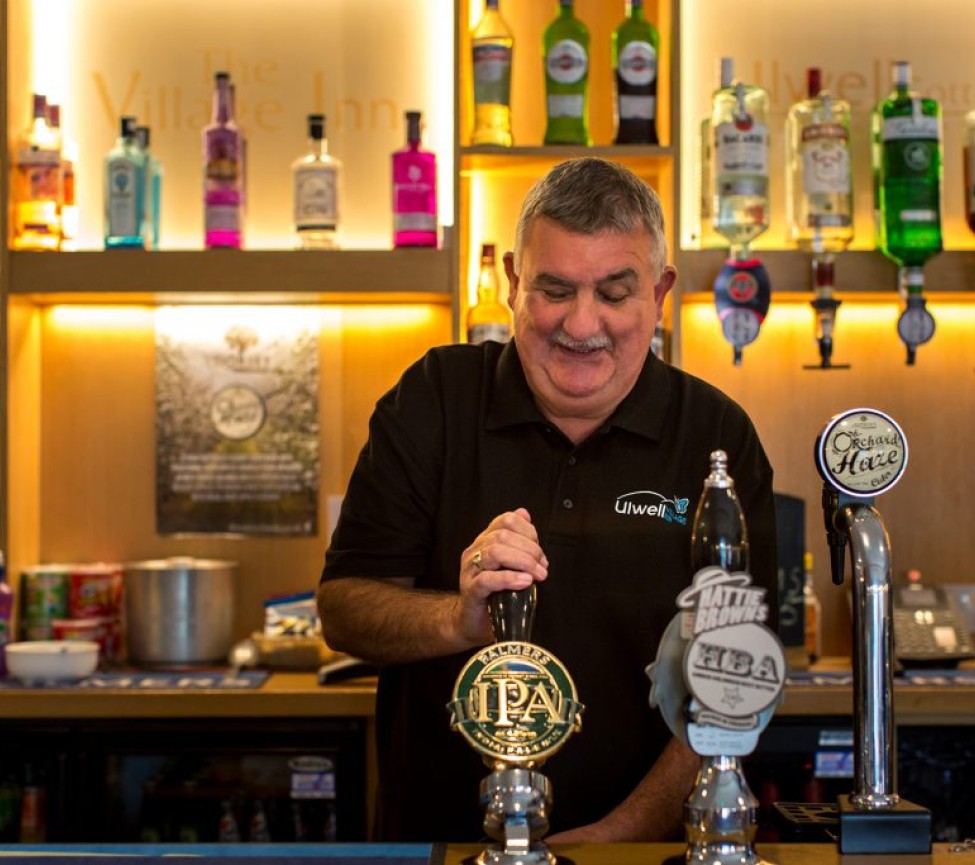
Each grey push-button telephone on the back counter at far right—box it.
[893,582,975,667]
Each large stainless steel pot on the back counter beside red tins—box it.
[125,557,237,667]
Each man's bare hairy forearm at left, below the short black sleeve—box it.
[318,577,475,664]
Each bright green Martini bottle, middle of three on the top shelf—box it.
[542,0,592,146]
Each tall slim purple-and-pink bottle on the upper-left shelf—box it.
[203,72,244,249]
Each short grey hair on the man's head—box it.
[515,156,667,277]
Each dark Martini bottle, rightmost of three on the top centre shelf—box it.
[611,0,660,144]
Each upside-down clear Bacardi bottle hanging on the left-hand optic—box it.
[711,62,769,248]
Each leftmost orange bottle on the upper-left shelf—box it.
[11,93,63,250]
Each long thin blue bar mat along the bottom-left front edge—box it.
[0,844,430,865]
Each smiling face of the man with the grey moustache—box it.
[504,217,676,435]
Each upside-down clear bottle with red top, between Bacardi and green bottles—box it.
[786,67,853,253]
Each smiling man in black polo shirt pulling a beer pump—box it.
[318,157,776,842]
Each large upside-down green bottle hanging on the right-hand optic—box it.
[871,60,942,267]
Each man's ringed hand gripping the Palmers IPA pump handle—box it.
[455,508,548,646]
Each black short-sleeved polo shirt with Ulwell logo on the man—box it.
[322,342,775,841]
